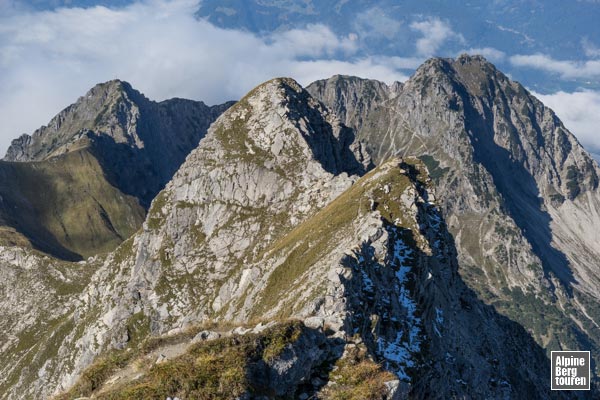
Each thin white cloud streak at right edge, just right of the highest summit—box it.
[510,54,600,79]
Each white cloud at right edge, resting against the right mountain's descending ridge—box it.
[534,90,600,154]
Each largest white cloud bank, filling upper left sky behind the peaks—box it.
[0,0,406,152]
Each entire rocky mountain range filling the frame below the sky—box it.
[0,56,600,399]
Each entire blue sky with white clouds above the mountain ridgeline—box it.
[0,0,600,159]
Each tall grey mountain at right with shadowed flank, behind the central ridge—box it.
[308,56,600,378]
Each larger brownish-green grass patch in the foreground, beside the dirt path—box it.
[63,321,305,400]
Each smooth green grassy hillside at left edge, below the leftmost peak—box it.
[0,149,145,259]
